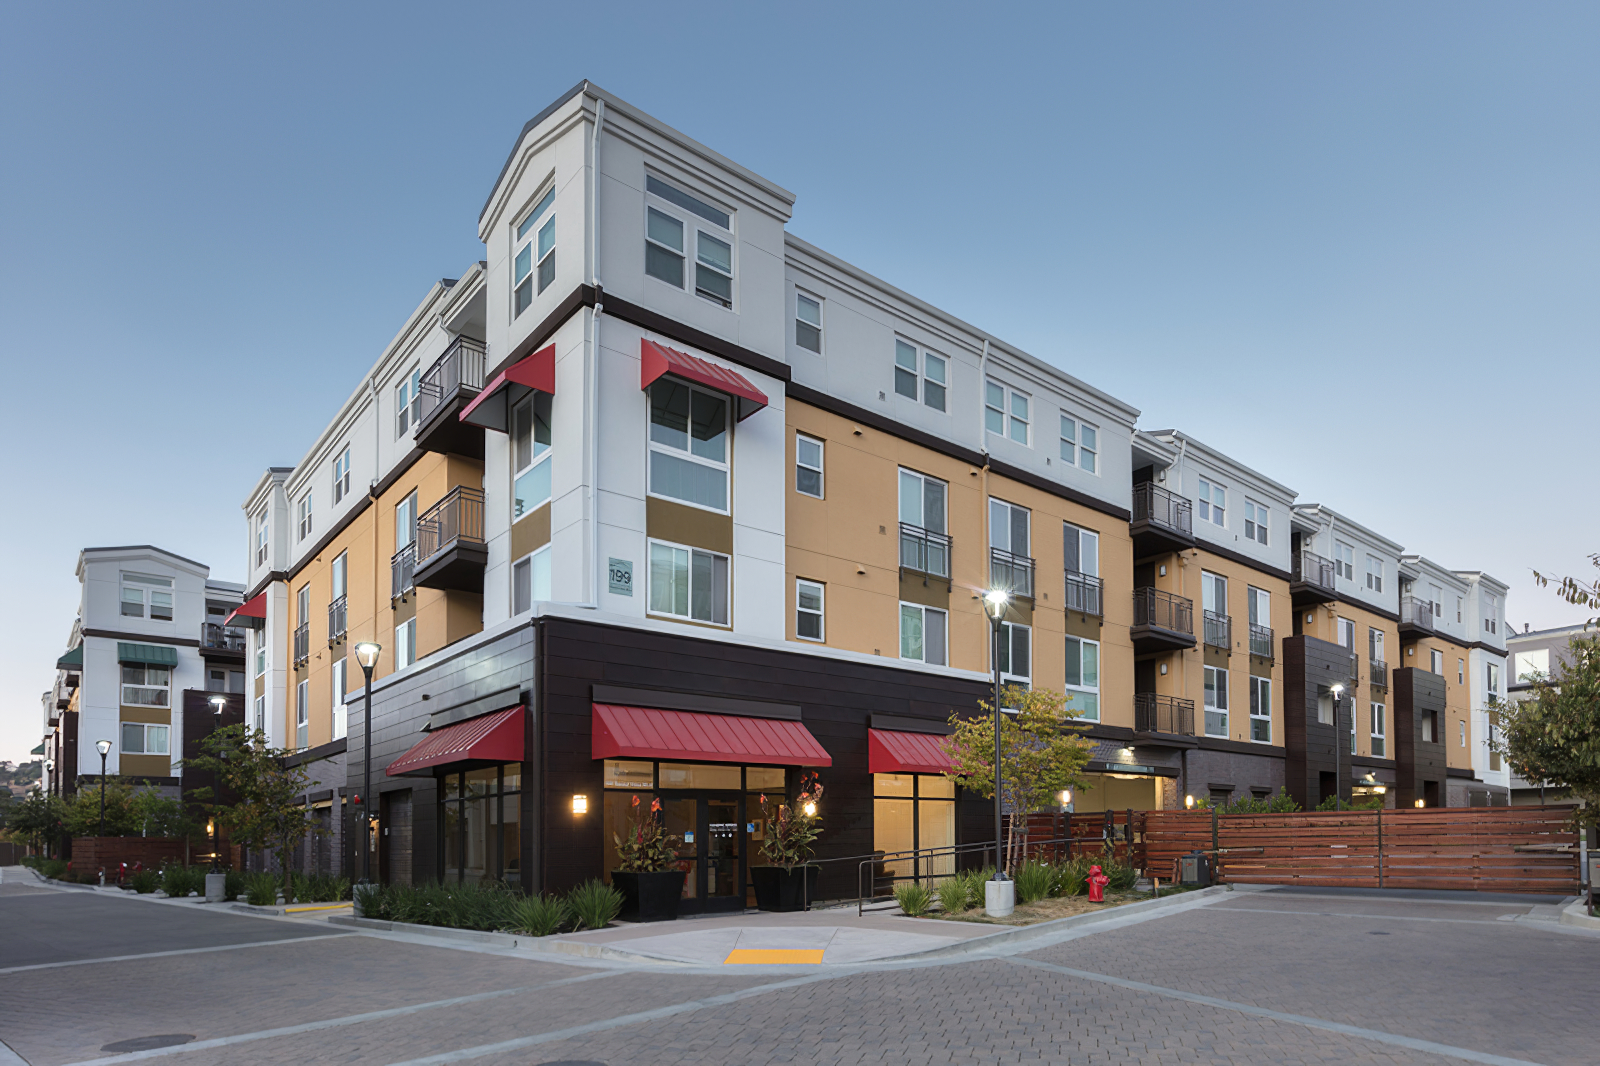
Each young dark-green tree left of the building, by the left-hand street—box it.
[184,725,326,898]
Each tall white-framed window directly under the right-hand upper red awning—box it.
[650,378,728,512]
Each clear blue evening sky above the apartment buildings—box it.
[0,2,1600,759]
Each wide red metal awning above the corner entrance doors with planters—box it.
[590,703,834,767]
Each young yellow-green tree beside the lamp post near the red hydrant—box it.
[942,685,1093,868]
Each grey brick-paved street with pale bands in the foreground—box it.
[0,885,1600,1066]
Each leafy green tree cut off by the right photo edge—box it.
[1491,633,1600,824]
